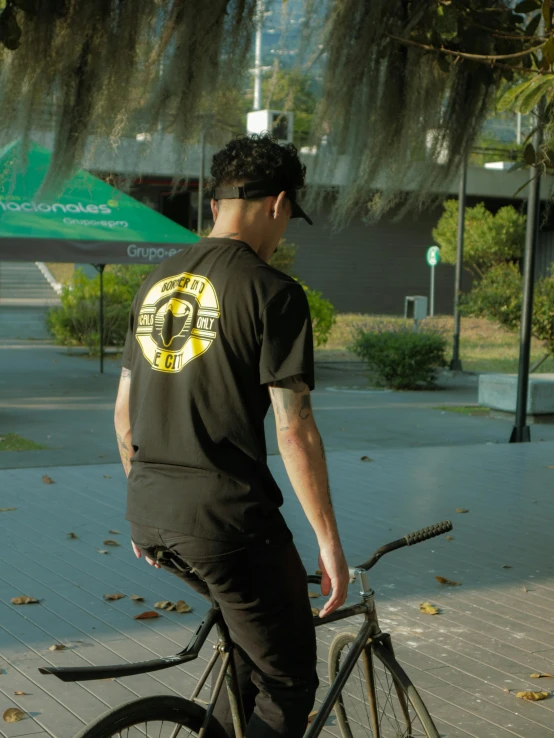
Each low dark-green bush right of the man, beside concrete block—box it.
[348,324,447,389]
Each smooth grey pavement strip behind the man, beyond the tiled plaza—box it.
[4,339,554,468]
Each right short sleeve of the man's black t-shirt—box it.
[260,284,315,390]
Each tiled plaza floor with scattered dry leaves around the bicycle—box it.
[0,443,554,738]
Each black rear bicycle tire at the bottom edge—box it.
[75,695,227,738]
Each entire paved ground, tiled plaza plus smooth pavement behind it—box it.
[0,330,554,738]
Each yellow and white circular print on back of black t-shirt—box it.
[135,272,221,374]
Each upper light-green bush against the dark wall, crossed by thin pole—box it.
[433,200,526,278]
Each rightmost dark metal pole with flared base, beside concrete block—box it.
[510,121,544,443]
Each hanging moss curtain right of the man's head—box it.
[309,0,514,225]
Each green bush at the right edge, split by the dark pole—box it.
[462,263,554,353]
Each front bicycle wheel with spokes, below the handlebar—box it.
[329,631,439,738]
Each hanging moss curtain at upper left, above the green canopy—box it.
[0,0,256,190]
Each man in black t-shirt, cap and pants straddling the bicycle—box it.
[115,135,348,738]
